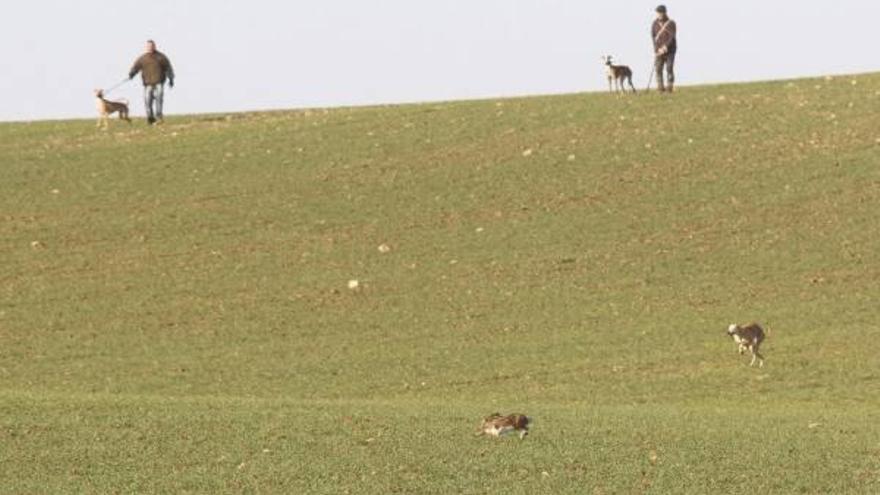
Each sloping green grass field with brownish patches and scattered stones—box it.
[0,75,880,494]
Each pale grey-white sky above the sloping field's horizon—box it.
[0,0,880,121]
